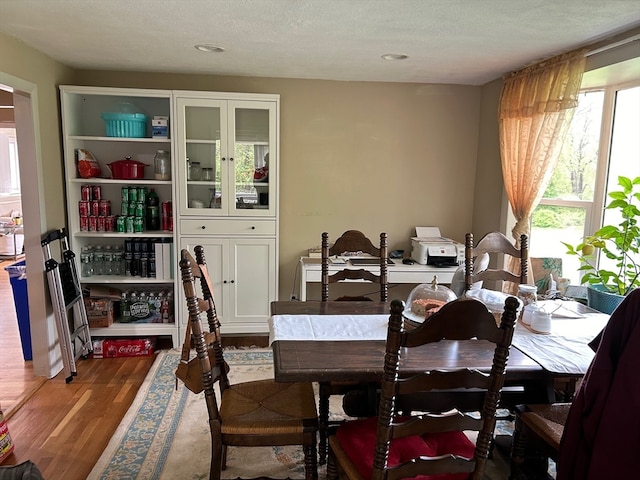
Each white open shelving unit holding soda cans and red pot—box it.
[60,86,181,346]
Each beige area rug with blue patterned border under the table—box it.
[88,348,510,480]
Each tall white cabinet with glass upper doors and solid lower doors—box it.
[174,91,279,334]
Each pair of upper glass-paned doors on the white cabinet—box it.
[176,92,278,217]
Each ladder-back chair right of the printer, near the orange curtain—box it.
[464,232,529,293]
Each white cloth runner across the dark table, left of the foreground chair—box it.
[269,314,389,345]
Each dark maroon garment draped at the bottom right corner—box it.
[557,289,640,480]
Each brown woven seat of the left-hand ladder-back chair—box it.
[220,380,318,436]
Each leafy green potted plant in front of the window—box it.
[562,176,640,313]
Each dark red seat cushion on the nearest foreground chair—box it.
[336,417,475,480]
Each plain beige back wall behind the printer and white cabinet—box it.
[75,71,501,299]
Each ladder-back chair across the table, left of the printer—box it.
[321,230,389,302]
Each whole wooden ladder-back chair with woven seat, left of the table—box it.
[180,246,318,480]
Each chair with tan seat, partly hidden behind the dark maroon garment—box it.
[509,403,571,480]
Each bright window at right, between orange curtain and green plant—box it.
[529,83,640,285]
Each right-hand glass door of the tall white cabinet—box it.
[229,101,276,215]
